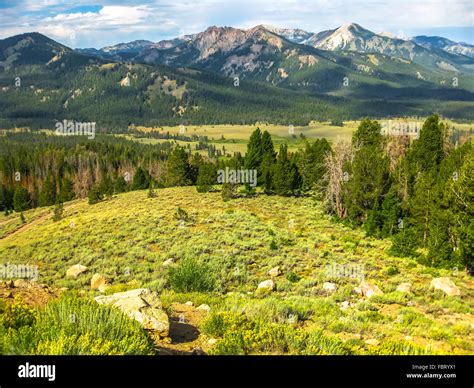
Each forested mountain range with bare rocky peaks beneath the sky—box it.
[0,23,474,127]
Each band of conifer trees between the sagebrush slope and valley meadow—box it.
[0,116,474,268]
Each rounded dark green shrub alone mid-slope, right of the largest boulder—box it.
[168,258,216,292]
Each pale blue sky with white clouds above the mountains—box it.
[0,0,474,48]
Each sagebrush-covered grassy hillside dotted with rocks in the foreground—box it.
[0,187,474,354]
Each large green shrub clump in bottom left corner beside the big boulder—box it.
[0,295,154,355]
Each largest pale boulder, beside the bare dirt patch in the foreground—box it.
[95,288,169,337]
